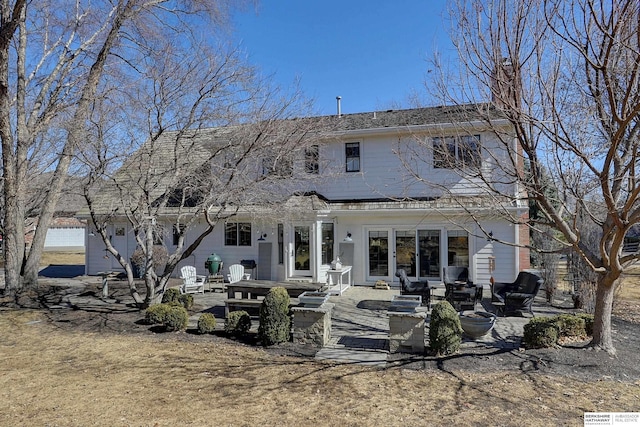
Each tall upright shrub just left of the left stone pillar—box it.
[258,286,291,345]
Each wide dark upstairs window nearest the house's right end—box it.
[433,135,482,169]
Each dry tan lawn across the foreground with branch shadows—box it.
[0,311,640,426]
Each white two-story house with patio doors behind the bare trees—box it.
[81,104,529,285]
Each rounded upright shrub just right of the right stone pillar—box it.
[429,301,462,356]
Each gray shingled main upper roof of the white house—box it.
[82,104,503,214]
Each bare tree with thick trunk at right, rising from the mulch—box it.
[410,0,640,353]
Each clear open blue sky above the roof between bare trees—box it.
[235,0,450,114]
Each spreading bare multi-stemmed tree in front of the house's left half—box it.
[79,31,324,306]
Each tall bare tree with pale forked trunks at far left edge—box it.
[0,0,252,293]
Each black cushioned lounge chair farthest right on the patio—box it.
[491,271,543,316]
